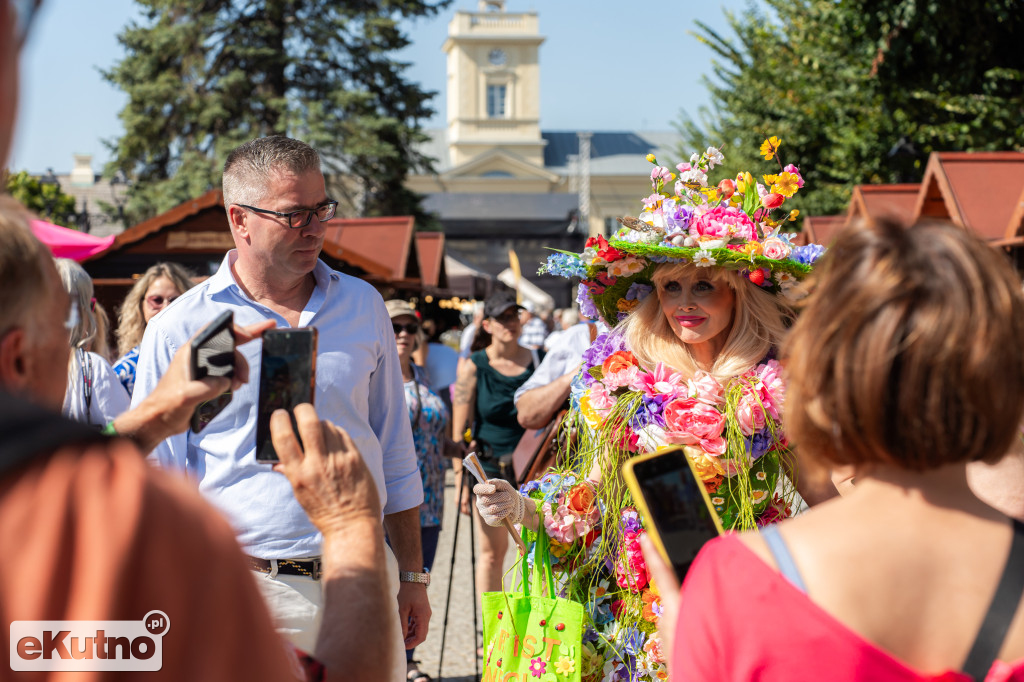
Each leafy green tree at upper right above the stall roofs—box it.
[678,0,1024,215]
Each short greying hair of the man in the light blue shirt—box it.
[221,135,321,210]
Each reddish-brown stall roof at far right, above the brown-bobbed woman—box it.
[914,152,1024,241]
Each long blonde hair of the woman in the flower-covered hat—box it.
[621,263,794,381]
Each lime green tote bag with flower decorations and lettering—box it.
[481,529,584,682]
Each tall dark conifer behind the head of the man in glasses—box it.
[103,0,451,223]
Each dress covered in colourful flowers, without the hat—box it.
[521,332,792,682]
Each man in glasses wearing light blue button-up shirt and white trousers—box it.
[133,136,430,676]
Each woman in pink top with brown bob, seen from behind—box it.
[647,216,1024,682]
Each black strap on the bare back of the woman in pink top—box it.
[964,519,1024,680]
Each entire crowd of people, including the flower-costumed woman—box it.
[0,0,1024,682]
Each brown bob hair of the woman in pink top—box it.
[783,220,1024,471]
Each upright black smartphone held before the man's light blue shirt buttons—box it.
[256,327,316,462]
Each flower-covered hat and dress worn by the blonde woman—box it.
[521,137,824,681]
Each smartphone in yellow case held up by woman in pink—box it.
[623,447,724,582]
